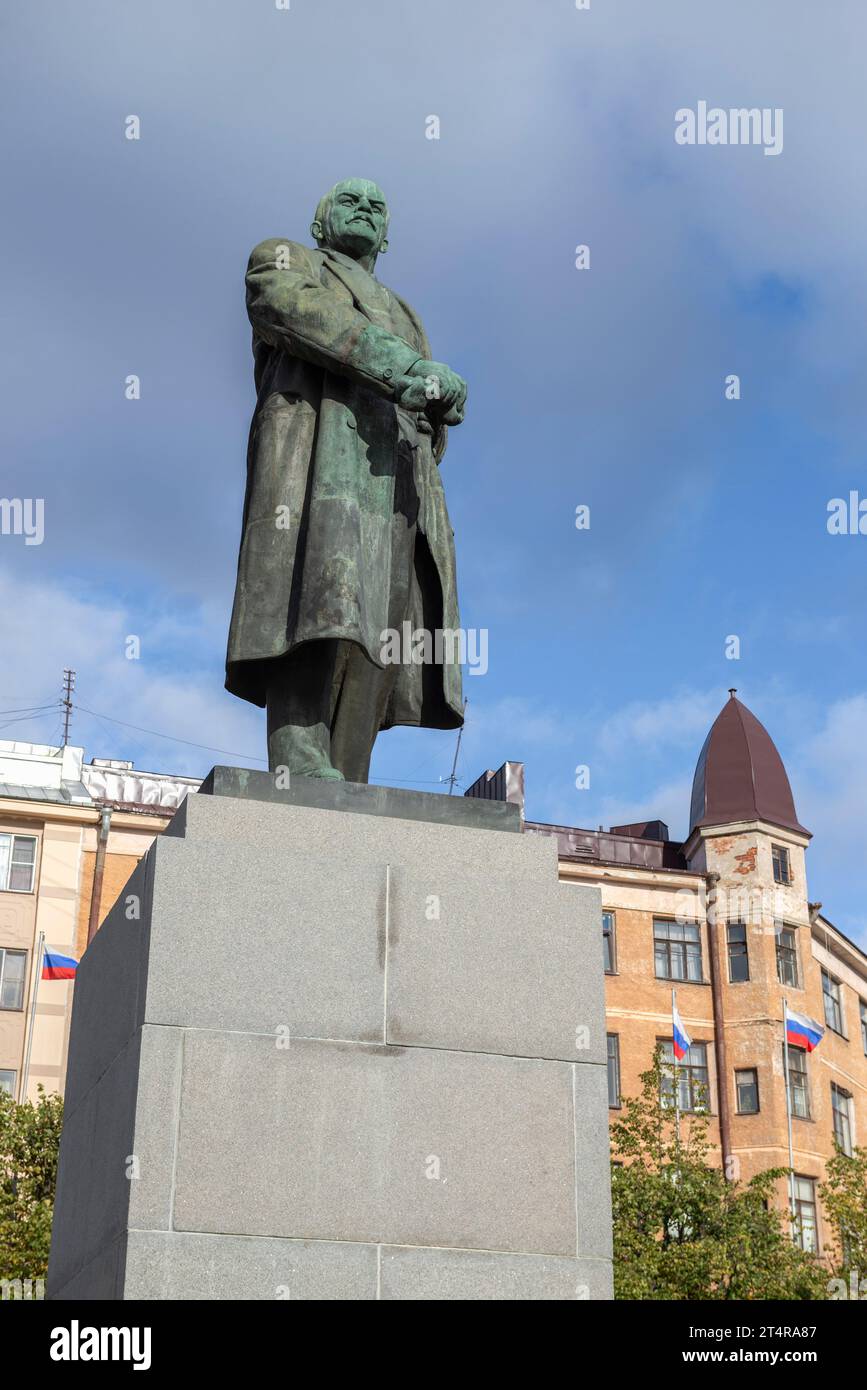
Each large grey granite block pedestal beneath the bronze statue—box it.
[49,769,611,1300]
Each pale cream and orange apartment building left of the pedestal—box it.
[0,741,199,1099]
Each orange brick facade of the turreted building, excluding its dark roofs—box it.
[560,824,867,1267]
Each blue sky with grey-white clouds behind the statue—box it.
[0,0,867,941]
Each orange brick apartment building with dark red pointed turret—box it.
[467,691,867,1250]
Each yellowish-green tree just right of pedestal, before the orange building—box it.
[611,1048,828,1300]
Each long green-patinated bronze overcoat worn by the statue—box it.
[226,239,463,728]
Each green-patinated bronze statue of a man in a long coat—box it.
[226,179,467,783]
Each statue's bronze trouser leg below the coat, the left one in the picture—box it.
[265,639,343,781]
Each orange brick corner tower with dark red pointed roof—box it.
[684,691,811,1217]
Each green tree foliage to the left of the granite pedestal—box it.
[0,1086,63,1280]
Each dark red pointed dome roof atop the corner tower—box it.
[689,694,810,835]
